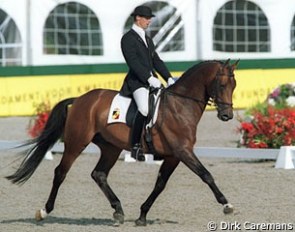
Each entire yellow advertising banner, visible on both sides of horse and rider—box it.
[0,69,295,116]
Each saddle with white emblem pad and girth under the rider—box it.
[107,88,162,154]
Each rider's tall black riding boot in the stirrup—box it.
[131,112,146,161]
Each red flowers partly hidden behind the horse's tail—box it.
[28,102,51,138]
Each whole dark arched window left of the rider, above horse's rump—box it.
[43,2,103,56]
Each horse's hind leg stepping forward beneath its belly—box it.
[91,143,124,224]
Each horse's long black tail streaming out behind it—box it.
[6,98,75,184]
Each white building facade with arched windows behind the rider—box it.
[0,0,295,66]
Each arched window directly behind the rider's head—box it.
[124,1,184,52]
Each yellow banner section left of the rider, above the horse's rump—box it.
[0,74,125,116]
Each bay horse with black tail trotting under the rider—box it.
[6,60,239,226]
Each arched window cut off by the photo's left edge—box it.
[0,9,22,66]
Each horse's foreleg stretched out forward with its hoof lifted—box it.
[179,152,233,214]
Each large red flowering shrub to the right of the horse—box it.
[238,84,295,148]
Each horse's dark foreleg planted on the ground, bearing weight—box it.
[135,157,179,226]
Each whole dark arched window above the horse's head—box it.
[213,0,270,52]
